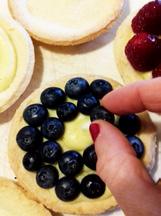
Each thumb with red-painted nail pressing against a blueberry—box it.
[90,120,158,211]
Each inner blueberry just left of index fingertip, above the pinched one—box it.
[77,94,99,115]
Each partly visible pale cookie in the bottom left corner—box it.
[0,178,51,216]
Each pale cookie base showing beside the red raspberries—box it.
[114,14,152,83]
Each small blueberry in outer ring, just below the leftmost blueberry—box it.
[23,151,42,171]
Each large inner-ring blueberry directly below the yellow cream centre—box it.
[58,151,83,176]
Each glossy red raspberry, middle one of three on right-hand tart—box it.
[125,33,161,71]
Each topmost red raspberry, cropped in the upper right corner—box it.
[132,0,161,35]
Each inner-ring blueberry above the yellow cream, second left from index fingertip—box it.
[56,102,78,121]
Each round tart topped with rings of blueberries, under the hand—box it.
[9,75,156,214]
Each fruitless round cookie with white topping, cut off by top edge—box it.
[9,0,124,46]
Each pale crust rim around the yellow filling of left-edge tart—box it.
[0,16,35,113]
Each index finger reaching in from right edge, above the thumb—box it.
[101,77,161,115]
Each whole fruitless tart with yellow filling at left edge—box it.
[0,15,35,113]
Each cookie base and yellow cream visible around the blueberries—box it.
[8,75,157,214]
